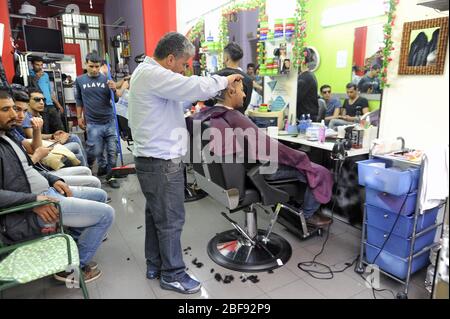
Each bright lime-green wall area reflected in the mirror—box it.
[306,0,386,109]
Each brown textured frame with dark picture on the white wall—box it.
[398,17,448,75]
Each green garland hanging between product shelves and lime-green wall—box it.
[293,0,308,68]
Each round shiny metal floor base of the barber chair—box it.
[208,230,292,273]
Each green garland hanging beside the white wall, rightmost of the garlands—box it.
[380,0,400,89]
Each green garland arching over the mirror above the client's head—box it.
[218,0,266,68]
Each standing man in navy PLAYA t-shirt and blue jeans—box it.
[75,53,120,188]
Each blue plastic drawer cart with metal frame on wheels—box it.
[355,156,443,299]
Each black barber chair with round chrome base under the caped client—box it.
[191,122,322,272]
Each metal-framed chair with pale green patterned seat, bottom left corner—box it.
[0,201,89,299]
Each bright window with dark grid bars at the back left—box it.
[62,14,104,59]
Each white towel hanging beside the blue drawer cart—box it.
[420,145,449,211]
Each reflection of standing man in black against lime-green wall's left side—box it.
[297,49,319,121]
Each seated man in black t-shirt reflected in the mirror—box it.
[330,83,369,130]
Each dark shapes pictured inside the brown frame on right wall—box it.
[408,29,440,66]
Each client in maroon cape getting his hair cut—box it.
[188,74,333,227]
